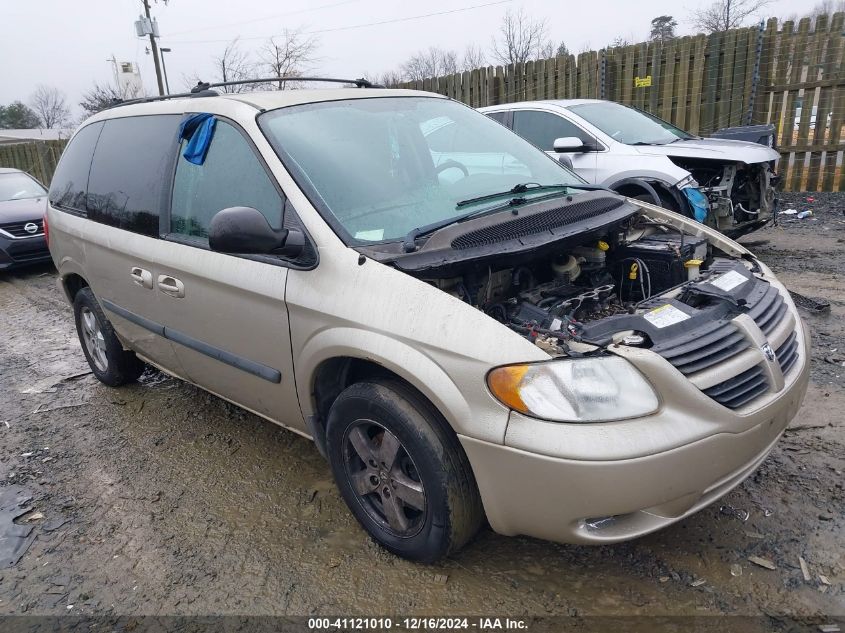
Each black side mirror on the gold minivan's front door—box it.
[208,207,305,257]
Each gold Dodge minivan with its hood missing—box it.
[45,82,809,561]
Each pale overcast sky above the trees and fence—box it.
[0,0,812,116]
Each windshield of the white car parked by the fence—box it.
[569,101,693,145]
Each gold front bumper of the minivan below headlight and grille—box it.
[460,310,810,544]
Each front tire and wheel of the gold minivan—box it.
[326,380,484,562]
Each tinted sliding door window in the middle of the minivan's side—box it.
[88,115,181,237]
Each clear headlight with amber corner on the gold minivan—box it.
[487,356,659,422]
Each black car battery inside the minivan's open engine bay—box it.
[610,232,707,294]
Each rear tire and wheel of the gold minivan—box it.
[73,287,145,387]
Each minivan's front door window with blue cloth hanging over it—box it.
[170,120,284,241]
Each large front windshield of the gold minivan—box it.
[259,97,583,244]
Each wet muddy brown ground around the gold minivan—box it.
[0,196,845,630]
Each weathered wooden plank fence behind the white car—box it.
[403,13,845,191]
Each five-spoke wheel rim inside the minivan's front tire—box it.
[344,420,426,538]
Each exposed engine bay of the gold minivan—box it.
[416,214,768,356]
